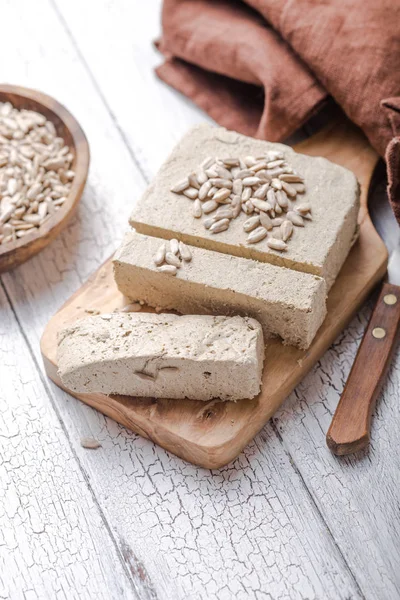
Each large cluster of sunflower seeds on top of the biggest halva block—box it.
[171,150,312,251]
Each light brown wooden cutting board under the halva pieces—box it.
[41,122,387,469]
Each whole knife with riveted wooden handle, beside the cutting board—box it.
[326,183,400,456]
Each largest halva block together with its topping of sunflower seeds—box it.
[130,125,359,288]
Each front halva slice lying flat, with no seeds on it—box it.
[57,313,264,400]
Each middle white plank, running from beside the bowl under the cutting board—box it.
[0,1,360,600]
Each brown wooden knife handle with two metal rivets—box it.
[326,283,400,456]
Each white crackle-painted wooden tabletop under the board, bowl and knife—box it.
[0,0,400,600]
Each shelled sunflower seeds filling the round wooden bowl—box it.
[0,102,75,244]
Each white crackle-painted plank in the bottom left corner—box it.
[0,287,138,600]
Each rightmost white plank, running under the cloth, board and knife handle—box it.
[52,0,400,599]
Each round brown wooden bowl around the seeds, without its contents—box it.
[0,85,90,273]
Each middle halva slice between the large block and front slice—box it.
[114,230,326,348]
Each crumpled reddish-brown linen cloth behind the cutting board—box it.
[157,0,400,222]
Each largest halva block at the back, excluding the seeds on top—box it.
[130,125,359,289]
